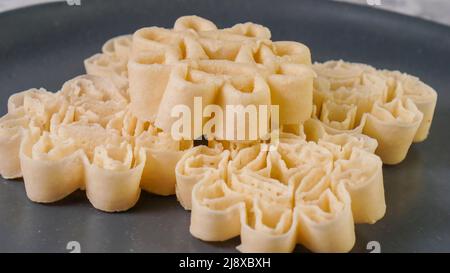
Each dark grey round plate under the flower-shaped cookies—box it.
[0,0,450,252]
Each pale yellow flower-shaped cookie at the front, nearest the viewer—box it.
[190,137,385,252]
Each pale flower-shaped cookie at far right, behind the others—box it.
[308,61,437,164]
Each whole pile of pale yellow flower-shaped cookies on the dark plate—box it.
[0,16,437,252]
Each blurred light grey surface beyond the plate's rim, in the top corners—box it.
[0,0,450,25]
